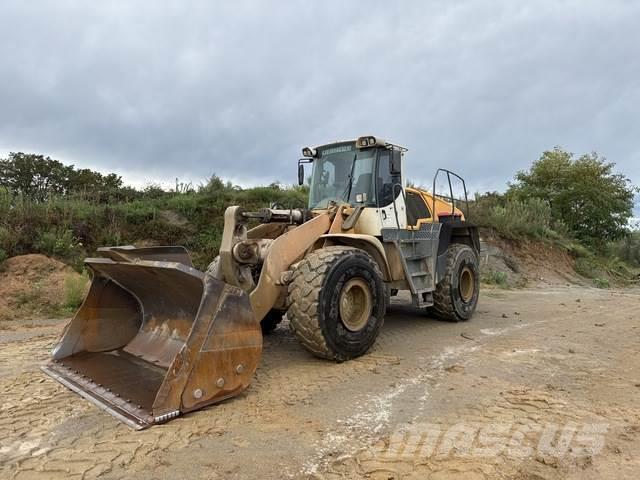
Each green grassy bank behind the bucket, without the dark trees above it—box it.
[0,177,307,271]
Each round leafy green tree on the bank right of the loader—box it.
[507,147,638,247]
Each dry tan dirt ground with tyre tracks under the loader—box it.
[0,287,640,480]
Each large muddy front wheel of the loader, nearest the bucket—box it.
[287,246,385,361]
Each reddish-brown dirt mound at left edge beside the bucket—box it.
[0,254,85,321]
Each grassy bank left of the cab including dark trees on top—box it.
[0,154,307,269]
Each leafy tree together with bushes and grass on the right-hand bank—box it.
[469,147,640,287]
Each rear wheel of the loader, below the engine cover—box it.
[431,243,480,322]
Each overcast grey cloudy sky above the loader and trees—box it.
[0,0,640,201]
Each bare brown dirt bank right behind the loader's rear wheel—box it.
[480,230,585,287]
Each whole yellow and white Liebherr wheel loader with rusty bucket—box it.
[42,136,480,429]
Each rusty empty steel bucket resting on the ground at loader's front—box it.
[42,247,262,429]
